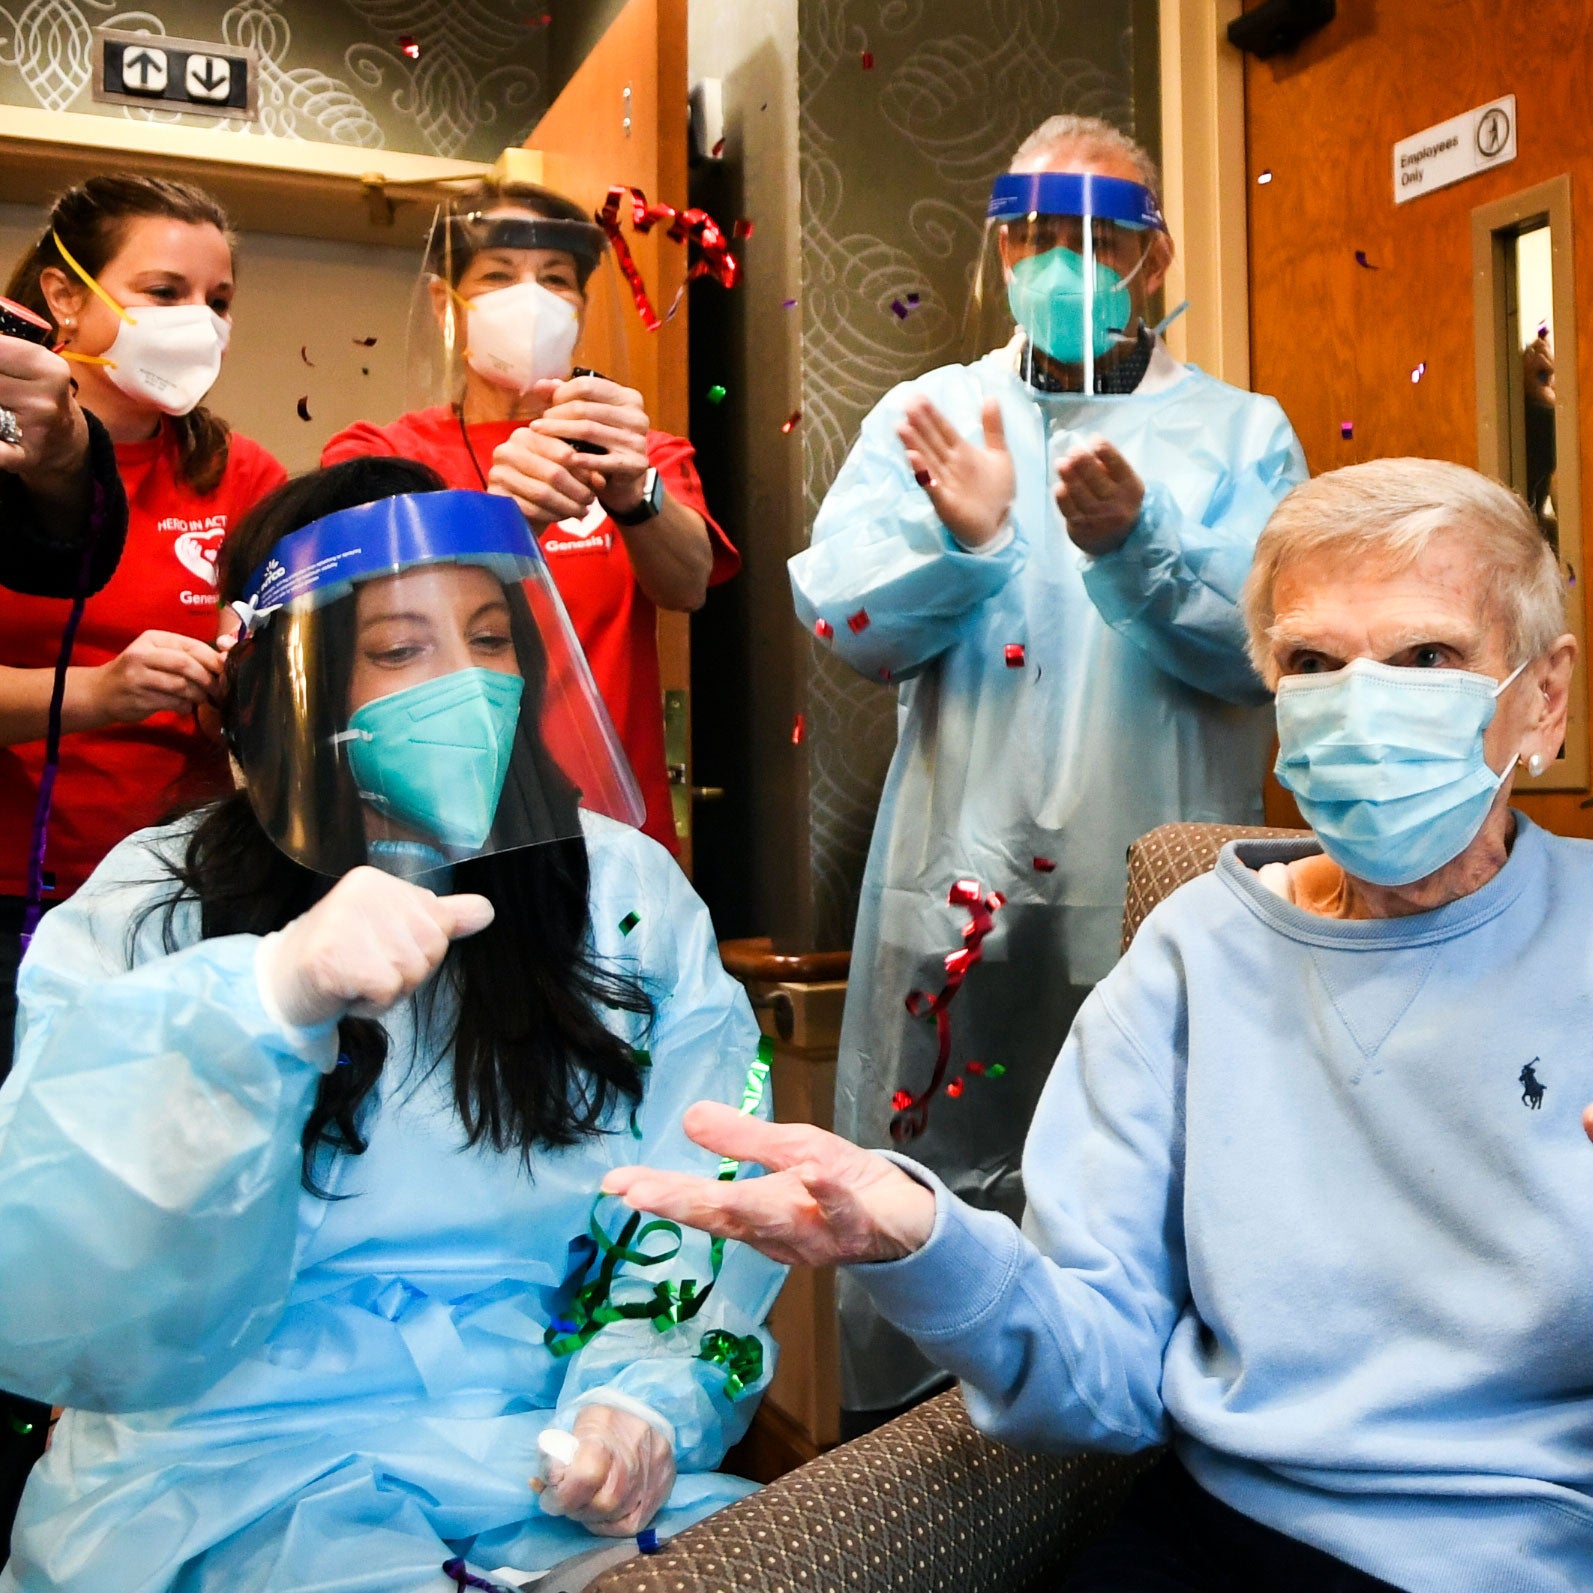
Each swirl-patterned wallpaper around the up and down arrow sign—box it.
[0,0,550,161]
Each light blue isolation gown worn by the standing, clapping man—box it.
[790,342,1306,1410]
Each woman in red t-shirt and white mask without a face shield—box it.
[0,175,287,1045]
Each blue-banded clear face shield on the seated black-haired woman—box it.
[228,492,642,878]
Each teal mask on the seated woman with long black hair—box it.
[338,669,526,852]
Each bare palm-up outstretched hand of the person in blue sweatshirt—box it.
[602,1101,935,1266]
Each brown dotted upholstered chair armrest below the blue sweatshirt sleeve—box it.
[591,1389,1160,1593]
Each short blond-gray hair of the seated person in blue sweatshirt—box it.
[1243,459,1568,685]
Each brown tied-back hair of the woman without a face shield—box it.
[5,172,234,495]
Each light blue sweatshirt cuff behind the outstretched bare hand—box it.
[852,1150,1023,1341]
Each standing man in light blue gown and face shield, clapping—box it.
[790,116,1306,1426]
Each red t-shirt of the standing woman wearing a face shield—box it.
[332,406,741,852]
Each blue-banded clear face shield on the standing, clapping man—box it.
[967,172,1166,393]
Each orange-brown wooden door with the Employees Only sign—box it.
[1246,0,1593,836]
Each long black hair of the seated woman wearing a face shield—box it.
[155,459,653,1193]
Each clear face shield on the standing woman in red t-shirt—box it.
[408,186,629,421]
